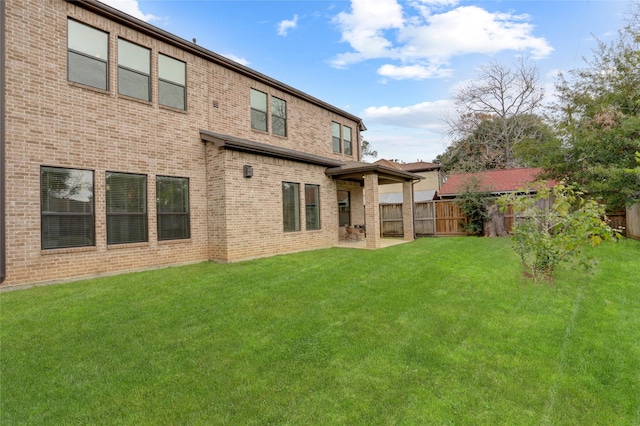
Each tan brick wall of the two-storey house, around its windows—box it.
[3,0,361,285]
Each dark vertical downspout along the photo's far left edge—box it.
[0,0,7,283]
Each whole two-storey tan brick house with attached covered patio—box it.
[0,0,421,286]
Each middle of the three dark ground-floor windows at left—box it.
[106,172,147,244]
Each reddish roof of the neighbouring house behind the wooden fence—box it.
[438,168,553,197]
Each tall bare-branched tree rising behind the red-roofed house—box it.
[439,59,548,171]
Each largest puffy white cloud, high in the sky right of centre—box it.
[332,0,553,79]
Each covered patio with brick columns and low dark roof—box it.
[325,161,422,249]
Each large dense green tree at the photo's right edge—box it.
[540,2,640,211]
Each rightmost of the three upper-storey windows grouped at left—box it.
[158,54,187,110]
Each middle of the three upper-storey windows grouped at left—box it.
[118,38,151,101]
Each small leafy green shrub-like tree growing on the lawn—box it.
[498,182,617,282]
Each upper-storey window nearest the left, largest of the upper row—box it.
[67,19,109,90]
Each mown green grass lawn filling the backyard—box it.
[0,238,640,425]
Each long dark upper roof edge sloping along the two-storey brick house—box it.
[66,0,367,131]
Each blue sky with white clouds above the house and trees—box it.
[102,0,631,162]
